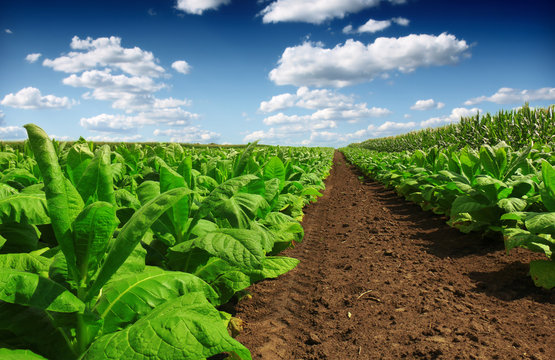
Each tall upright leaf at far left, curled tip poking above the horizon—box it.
[24,124,84,277]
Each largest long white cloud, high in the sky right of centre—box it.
[269,33,469,87]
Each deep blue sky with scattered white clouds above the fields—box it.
[0,0,555,147]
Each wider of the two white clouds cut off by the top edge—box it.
[260,0,405,24]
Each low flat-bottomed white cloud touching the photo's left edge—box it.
[0,87,76,109]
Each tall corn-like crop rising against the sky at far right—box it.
[350,105,555,152]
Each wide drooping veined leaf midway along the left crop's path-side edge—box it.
[193,229,264,269]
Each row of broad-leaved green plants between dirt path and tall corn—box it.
[342,142,555,289]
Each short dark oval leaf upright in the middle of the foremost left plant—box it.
[73,202,118,284]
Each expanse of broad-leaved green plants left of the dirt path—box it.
[0,125,332,359]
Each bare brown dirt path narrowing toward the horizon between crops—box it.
[236,153,555,360]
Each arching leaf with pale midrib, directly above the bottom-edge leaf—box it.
[95,267,218,334]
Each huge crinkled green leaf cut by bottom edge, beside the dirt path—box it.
[83,293,251,360]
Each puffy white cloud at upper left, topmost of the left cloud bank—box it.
[42,36,164,77]
